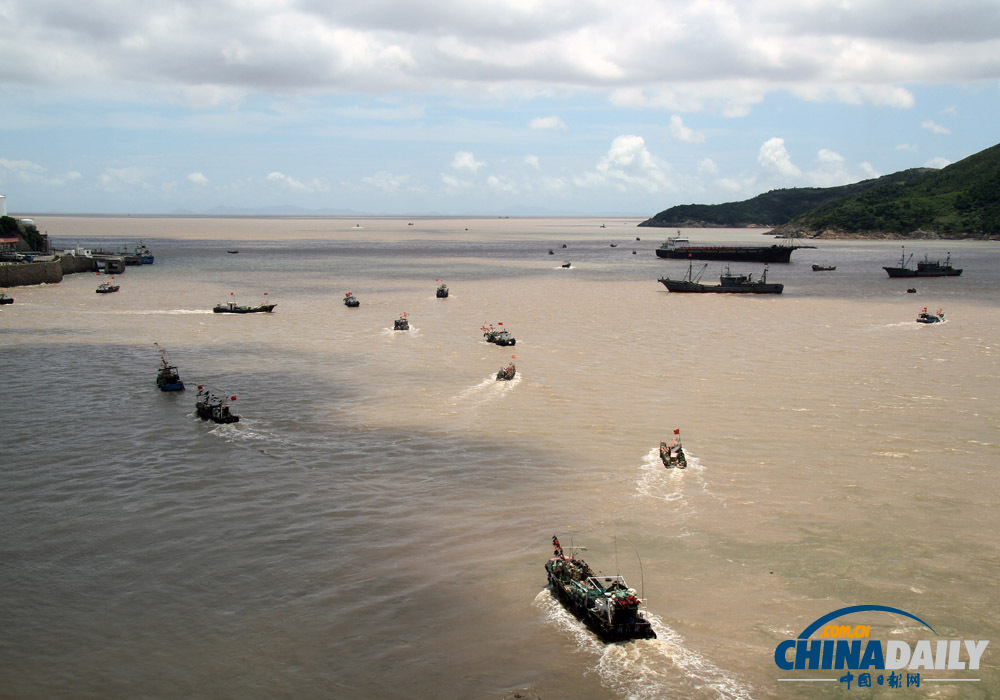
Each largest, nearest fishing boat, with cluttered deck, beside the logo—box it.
[545,535,656,642]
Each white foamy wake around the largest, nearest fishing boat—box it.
[534,592,753,700]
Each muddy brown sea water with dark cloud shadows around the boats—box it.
[0,216,1000,700]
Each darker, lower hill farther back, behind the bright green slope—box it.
[639,168,933,228]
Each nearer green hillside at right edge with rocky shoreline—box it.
[776,145,1000,239]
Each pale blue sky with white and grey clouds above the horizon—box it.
[0,0,1000,217]
